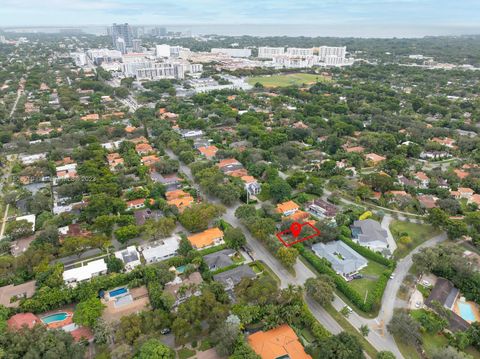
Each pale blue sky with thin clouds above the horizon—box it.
[0,0,480,35]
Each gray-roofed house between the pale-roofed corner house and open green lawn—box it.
[350,219,392,256]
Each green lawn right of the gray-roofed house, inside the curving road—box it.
[390,221,441,259]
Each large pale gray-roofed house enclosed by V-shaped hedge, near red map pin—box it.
[312,241,368,280]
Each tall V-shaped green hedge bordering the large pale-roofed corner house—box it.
[297,246,392,312]
